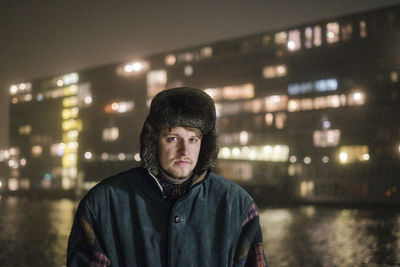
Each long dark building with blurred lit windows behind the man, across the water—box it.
[8,6,400,201]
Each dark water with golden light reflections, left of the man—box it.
[0,197,75,266]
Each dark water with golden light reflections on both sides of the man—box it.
[0,197,400,267]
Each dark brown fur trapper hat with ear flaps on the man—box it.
[140,87,218,176]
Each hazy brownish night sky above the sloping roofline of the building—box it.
[0,0,400,149]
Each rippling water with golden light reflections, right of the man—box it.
[260,206,400,267]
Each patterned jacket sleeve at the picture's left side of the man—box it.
[67,202,110,267]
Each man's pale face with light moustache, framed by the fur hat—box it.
[158,127,202,179]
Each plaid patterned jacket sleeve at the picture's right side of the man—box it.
[234,202,268,267]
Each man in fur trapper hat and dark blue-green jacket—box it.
[67,87,267,267]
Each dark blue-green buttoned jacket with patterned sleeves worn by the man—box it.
[67,167,267,267]
